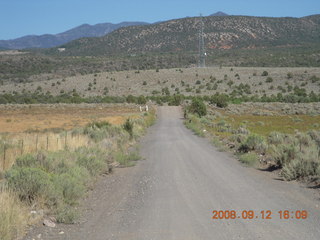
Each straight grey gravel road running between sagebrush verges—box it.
[26,107,320,240]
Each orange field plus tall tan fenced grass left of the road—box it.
[0,104,140,170]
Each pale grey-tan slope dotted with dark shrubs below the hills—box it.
[1,67,320,97]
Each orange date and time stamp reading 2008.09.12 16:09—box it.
[212,210,308,220]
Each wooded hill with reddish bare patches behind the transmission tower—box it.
[46,15,320,56]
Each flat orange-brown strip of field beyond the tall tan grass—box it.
[0,104,139,133]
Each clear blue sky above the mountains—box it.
[0,0,320,40]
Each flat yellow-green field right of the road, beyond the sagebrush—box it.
[213,103,320,136]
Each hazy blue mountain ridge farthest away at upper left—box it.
[0,22,148,49]
